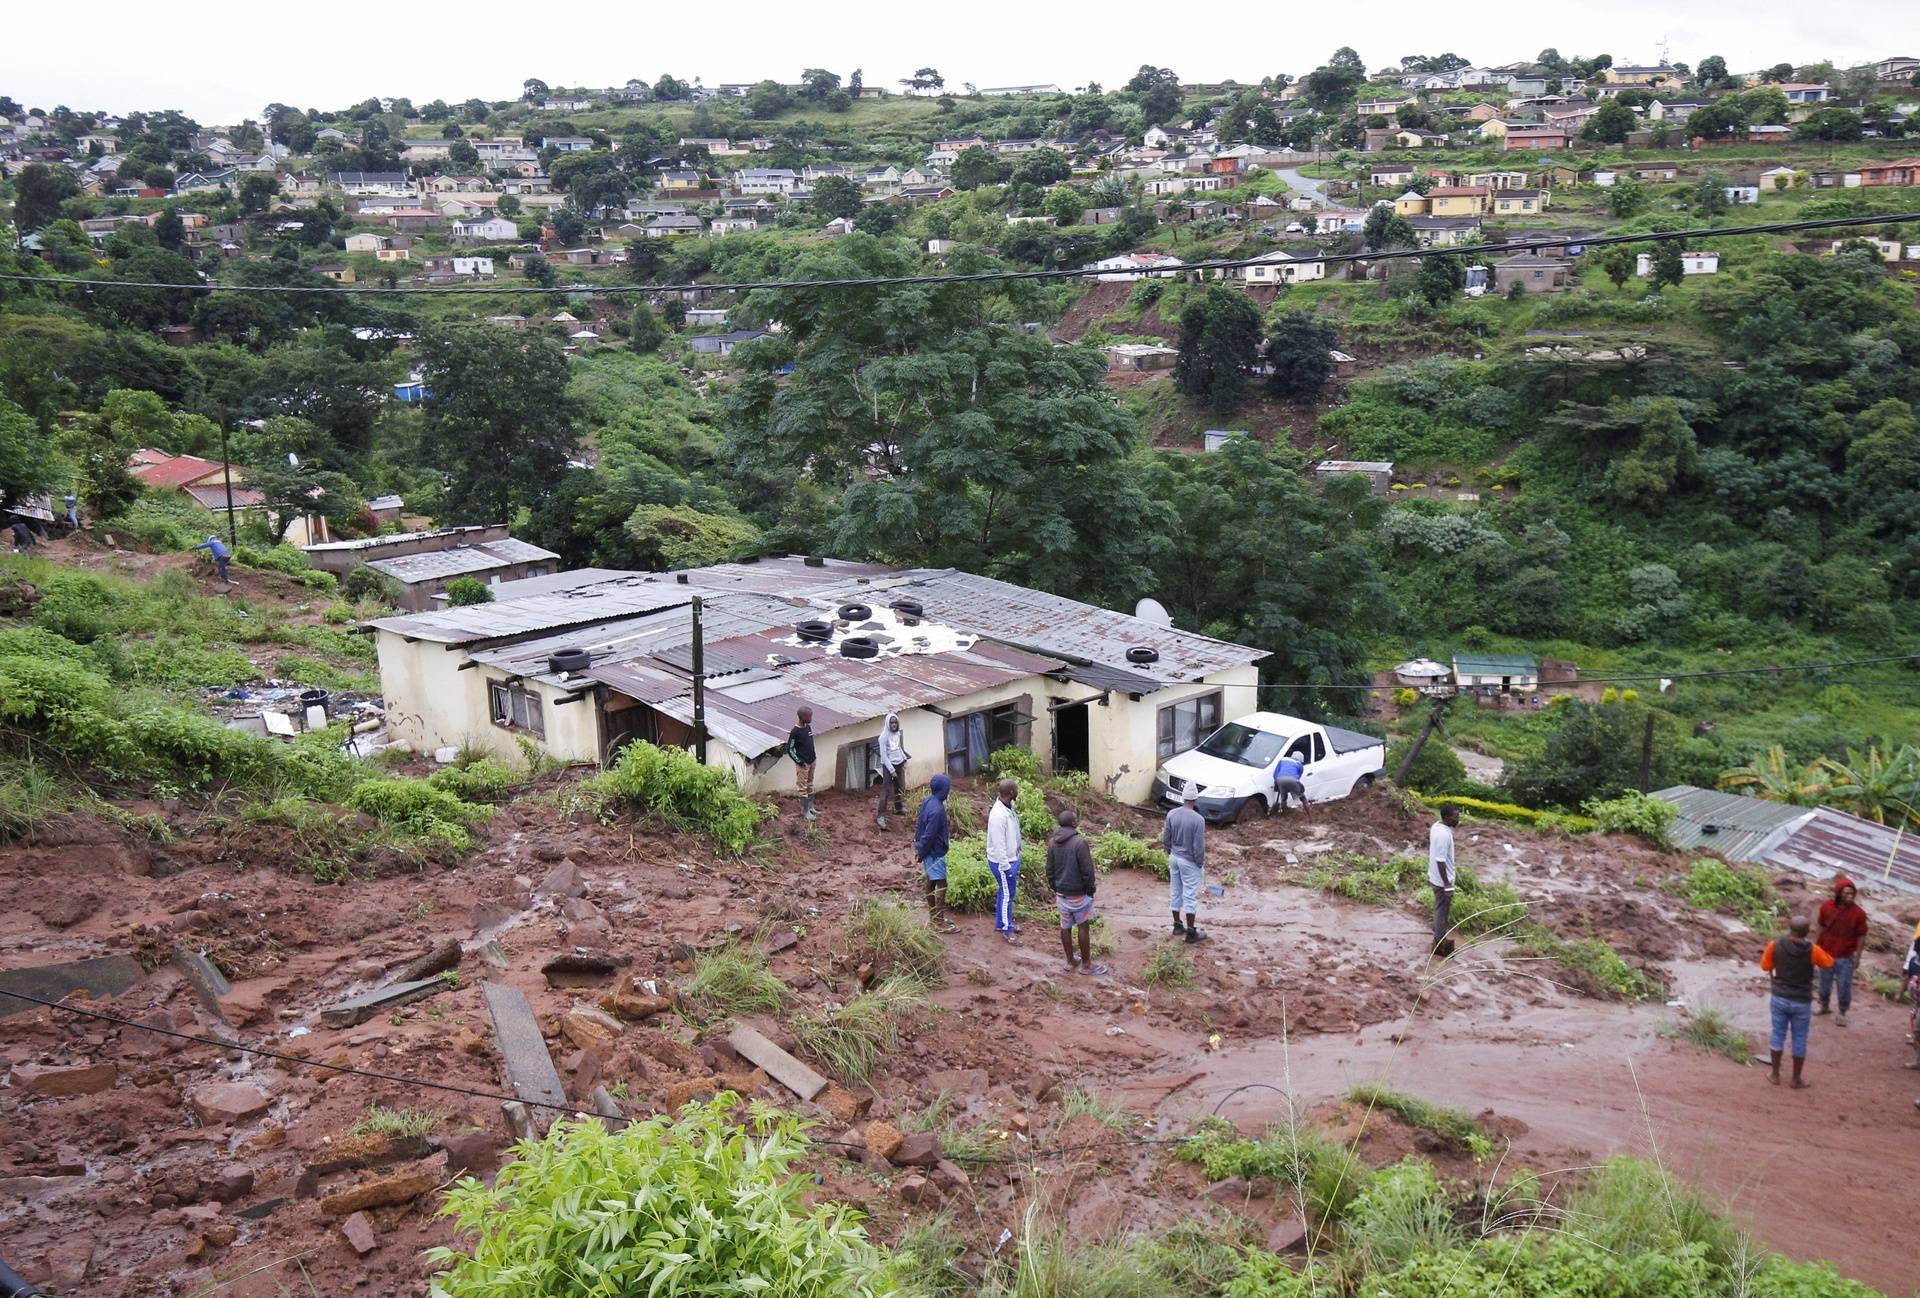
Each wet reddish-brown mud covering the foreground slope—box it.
[0,764,1920,1298]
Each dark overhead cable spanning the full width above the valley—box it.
[0,211,1920,298]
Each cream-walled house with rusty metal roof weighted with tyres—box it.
[371,557,1265,801]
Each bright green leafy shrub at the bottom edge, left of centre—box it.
[426,1093,897,1298]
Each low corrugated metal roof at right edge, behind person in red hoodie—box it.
[1653,783,1920,893]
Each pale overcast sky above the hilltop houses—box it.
[0,0,1920,125]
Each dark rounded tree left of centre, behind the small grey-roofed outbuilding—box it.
[419,325,576,522]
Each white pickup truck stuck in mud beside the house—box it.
[1154,712,1386,822]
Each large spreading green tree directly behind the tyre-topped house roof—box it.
[726,234,1154,601]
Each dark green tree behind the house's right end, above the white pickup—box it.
[1148,438,1394,714]
